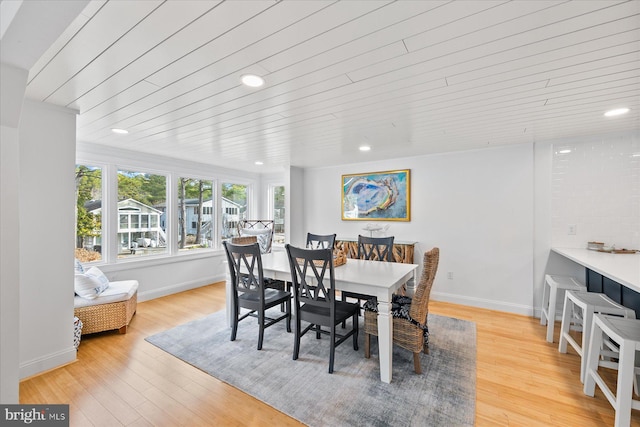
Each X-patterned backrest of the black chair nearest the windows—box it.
[222,242,264,302]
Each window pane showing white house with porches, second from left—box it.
[117,170,167,258]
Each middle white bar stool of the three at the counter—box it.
[558,291,636,383]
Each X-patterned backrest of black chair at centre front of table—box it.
[285,244,336,317]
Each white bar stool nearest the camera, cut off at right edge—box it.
[584,314,640,427]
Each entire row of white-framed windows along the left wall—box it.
[74,153,262,264]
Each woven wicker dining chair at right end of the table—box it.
[364,248,440,374]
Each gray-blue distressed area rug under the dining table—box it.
[146,311,476,426]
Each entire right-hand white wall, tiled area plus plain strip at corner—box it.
[534,132,640,317]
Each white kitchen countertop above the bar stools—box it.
[551,248,640,292]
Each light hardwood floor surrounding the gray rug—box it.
[20,283,640,427]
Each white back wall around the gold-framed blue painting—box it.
[304,144,534,314]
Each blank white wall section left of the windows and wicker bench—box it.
[19,101,76,378]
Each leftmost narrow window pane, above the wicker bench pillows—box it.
[75,165,102,262]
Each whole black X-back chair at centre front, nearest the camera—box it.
[285,244,360,374]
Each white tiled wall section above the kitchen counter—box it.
[551,132,640,249]
